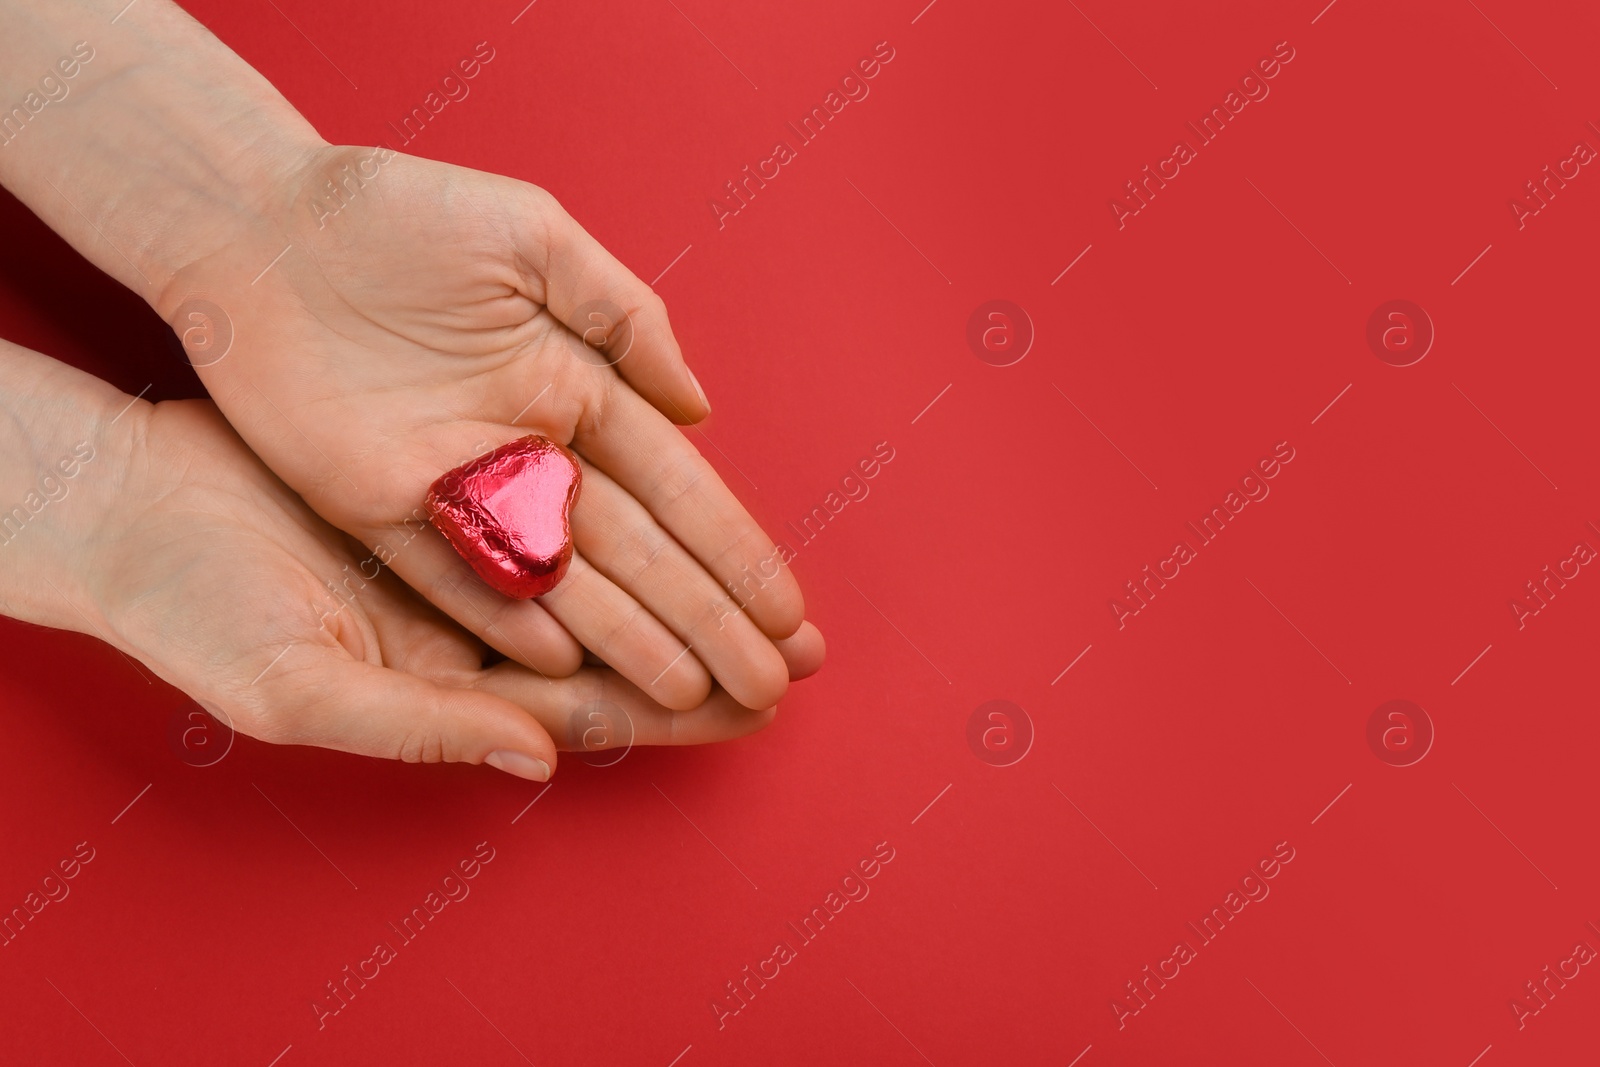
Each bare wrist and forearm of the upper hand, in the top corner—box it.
[0,0,325,300]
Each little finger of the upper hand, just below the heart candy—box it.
[371,525,584,677]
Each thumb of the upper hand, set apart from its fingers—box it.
[523,186,710,422]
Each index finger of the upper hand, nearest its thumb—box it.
[573,389,805,638]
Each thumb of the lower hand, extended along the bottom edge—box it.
[233,645,555,782]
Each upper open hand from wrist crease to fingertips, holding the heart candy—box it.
[157,146,822,709]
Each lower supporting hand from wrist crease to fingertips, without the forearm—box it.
[75,402,816,781]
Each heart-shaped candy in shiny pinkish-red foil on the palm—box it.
[427,434,584,600]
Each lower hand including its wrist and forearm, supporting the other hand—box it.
[0,342,816,781]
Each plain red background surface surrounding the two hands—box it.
[0,0,1600,1067]
